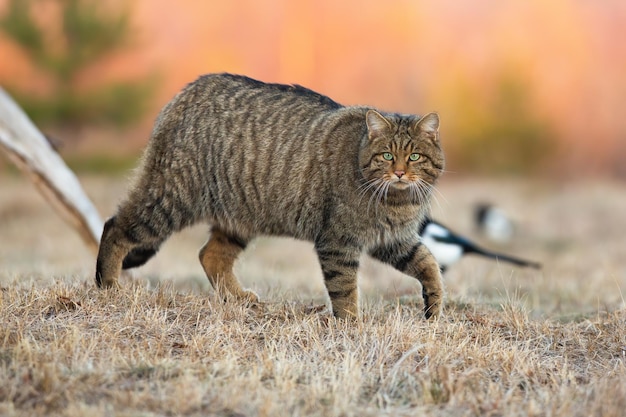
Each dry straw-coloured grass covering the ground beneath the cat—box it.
[0,174,626,416]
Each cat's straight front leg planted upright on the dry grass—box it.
[315,242,361,319]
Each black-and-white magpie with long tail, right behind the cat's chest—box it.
[420,218,541,273]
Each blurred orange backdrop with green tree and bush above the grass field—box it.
[0,0,626,178]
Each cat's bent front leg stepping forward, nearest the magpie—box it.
[370,242,443,319]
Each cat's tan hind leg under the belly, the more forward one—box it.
[199,227,259,302]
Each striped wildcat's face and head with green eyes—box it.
[359,110,444,194]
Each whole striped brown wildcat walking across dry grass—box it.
[96,74,444,318]
